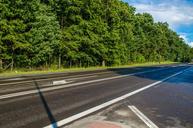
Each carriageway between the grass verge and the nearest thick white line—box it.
[0,65,193,128]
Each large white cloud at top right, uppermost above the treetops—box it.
[133,2,193,28]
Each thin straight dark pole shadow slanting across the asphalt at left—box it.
[34,80,58,128]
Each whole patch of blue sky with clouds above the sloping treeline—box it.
[123,0,193,47]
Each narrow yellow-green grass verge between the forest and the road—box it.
[0,61,176,77]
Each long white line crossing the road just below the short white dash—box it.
[0,69,170,100]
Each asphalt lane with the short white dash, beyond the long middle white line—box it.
[0,66,172,95]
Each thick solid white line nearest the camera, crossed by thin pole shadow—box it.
[44,69,187,128]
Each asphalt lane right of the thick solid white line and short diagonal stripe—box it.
[129,65,193,128]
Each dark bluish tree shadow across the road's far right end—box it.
[108,65,193,84]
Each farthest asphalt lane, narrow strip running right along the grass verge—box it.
[0,64,181,85]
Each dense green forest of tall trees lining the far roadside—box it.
[0,0,193,70]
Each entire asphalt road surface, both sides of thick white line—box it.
[0,65,193,128]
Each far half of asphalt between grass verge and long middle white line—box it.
[0,64,172,95]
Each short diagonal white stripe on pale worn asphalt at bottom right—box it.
[128,105,159,128]
